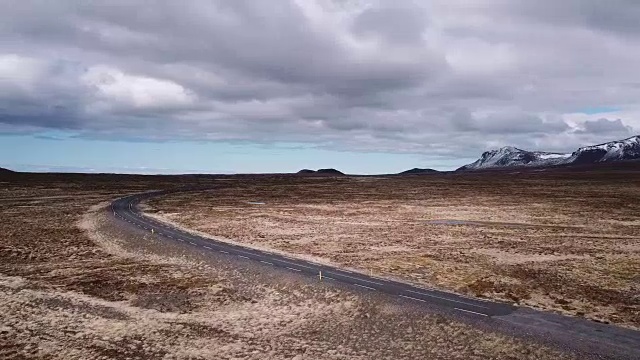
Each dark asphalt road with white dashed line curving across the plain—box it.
[111,191,640,359]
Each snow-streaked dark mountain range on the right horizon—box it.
[458,136,640,170]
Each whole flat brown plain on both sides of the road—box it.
[0,169,640,360]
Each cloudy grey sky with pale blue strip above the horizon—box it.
[0,0,640,173]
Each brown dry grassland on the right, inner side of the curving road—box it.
[149,170,640,328]
